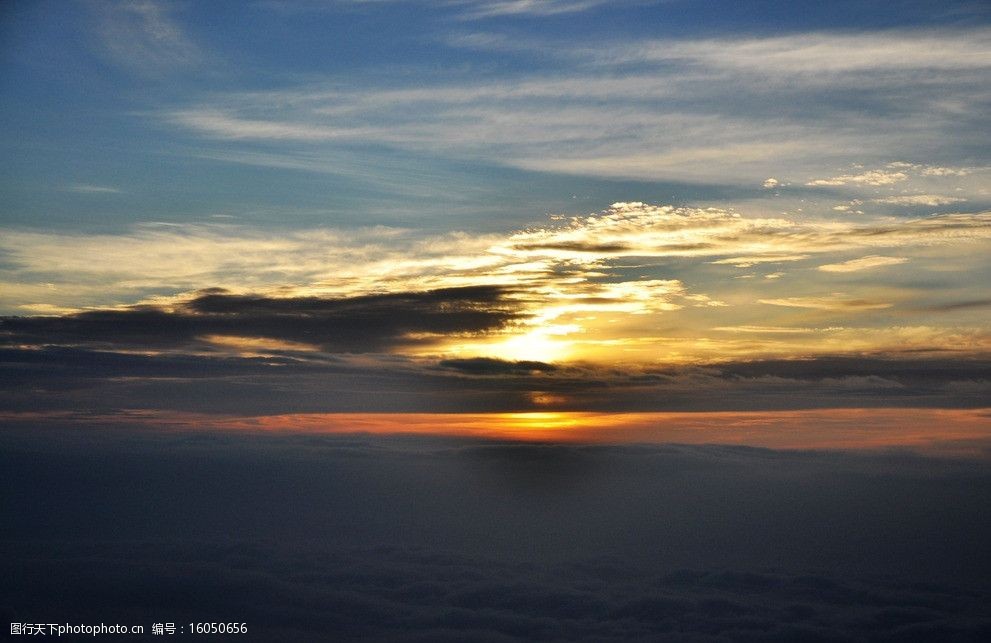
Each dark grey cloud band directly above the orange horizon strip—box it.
[0,346,991,415]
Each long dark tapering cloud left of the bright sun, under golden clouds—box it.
[0,286,520,353]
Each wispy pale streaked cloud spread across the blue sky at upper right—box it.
[160,26,989,184]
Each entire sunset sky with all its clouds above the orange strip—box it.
[0,0,991,442]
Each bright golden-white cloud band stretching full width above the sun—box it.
[0,202,991,306]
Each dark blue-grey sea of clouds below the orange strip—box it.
[0,427,991,643]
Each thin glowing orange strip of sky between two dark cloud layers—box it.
[9,408,991,455]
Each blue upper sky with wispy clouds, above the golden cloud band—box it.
[0,0,991,232]
